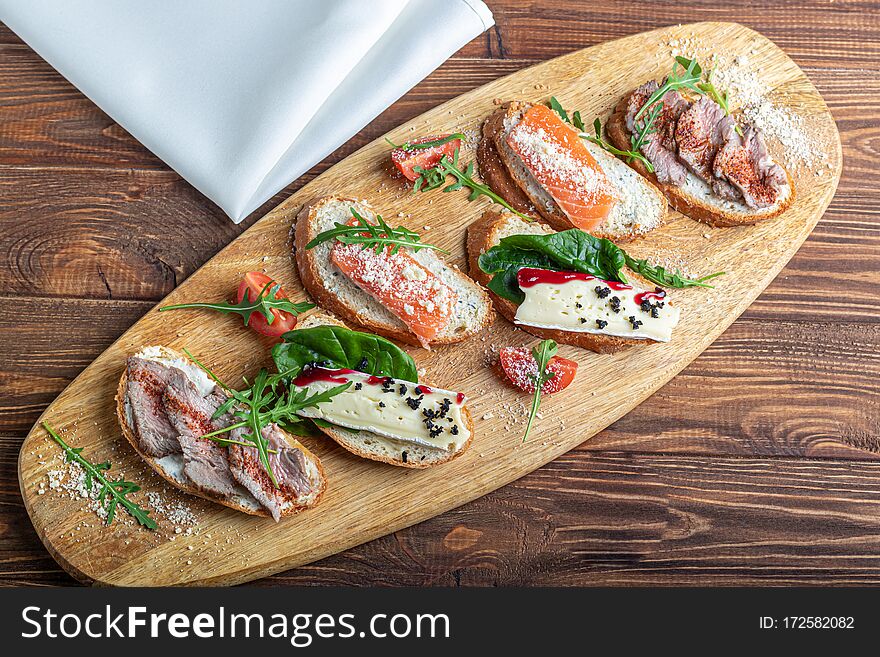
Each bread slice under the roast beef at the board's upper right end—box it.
[605,92,795,228]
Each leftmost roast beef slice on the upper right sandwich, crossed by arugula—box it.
[626,80,690,185]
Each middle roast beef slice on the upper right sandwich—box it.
[675,96,734,182]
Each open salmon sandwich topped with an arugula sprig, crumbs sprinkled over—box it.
[293,196,494,349]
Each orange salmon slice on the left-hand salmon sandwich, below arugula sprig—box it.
[330,219,456,349]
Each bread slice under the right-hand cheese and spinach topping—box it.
[467,210,651,354]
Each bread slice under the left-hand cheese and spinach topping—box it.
[297,313,474,469]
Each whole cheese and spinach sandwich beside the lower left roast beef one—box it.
[272,314,474,468]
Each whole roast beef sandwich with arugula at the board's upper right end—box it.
[606,57,795,227]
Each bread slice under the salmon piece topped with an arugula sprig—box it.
[294,196,495,346]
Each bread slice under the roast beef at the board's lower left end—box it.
[116,347,327,517]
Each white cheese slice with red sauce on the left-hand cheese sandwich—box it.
[294,368,470,451]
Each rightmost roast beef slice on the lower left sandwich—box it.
[229,424,315,521]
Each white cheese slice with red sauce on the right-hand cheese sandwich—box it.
[514,269,680,342]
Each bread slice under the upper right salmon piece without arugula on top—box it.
[477,101,666,241]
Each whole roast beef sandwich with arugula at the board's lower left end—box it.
[116,346,327,521]
